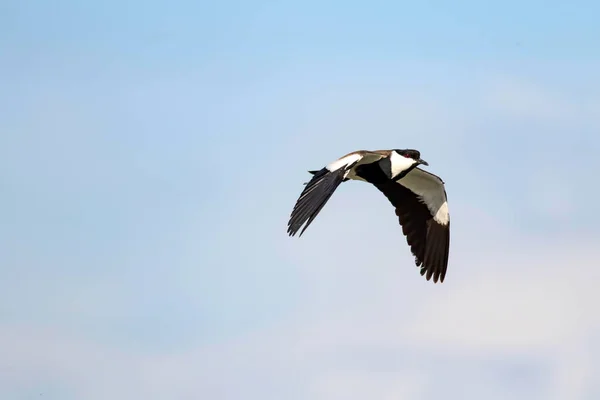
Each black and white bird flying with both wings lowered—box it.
[288,149,450,283]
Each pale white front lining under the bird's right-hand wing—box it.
[398,168,450,225]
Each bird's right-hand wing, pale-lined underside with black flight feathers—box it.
[374,168,450,282]
